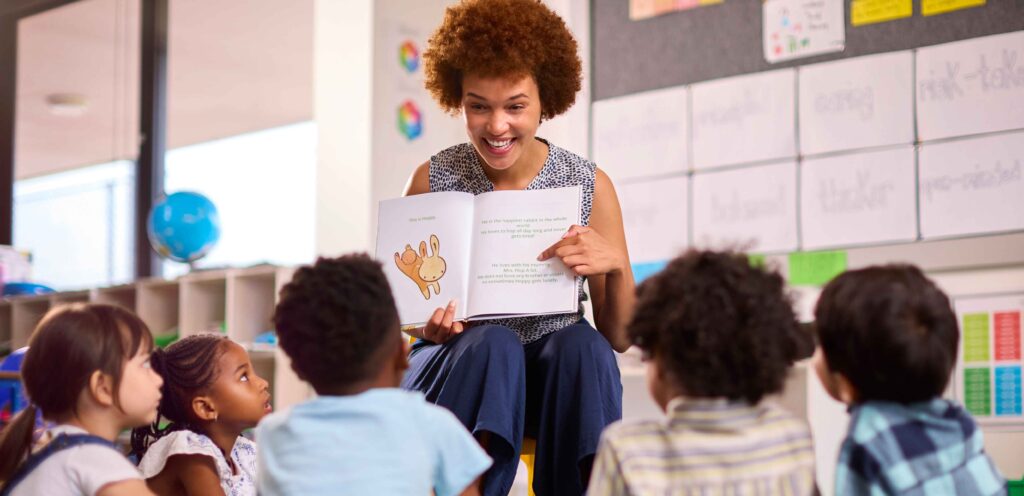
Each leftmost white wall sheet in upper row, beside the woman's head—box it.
[593,86,689,180]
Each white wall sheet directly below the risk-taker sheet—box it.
[918,132,1024,239]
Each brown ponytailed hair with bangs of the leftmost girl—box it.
[0,303,153,481]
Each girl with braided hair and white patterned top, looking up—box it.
[132,334,270,496]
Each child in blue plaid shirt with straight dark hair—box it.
[814,265,1007,495]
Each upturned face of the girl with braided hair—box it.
[210,341,270,428]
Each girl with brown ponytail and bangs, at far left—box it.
[0,303,162,496]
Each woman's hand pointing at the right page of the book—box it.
[537,224,626,276]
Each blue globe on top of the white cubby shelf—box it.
[146,192,220,262]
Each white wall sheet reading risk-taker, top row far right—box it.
[916,31,1024,141]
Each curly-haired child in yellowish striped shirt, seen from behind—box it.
[587,251,815,495]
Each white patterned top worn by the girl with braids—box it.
[138,430,256,496]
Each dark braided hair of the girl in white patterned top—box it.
[131,333,228,459]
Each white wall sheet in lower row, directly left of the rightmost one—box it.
[800,144,918,249]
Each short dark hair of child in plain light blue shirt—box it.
[273,253,398,394]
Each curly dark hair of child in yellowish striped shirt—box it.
[628,250,811,404]
